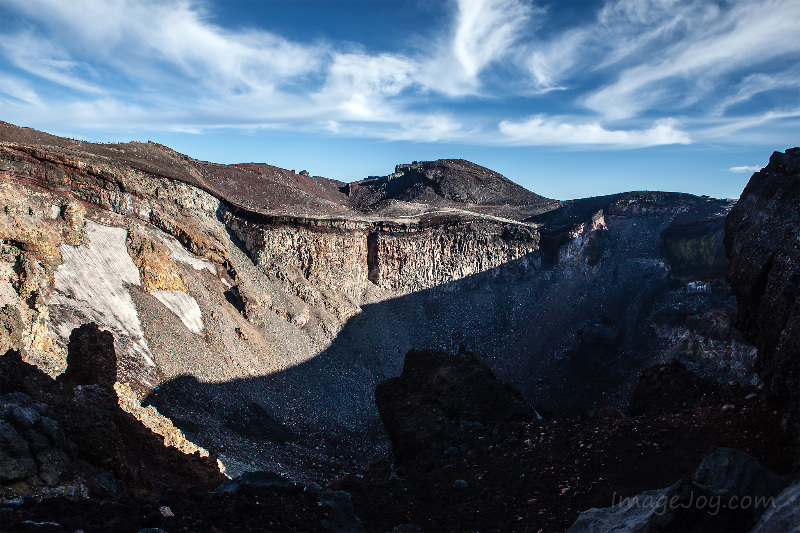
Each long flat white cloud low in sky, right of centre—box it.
[499,115,691,148]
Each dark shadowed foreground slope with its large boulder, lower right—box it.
[344,348,794,531]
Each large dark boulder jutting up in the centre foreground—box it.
[375,349,536,462]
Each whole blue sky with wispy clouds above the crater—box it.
[0,0,800,199]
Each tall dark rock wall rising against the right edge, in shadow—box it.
[725,148,800,437]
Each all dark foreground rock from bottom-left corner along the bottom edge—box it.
[0,324,363,532]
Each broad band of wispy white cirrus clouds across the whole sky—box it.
[0,0,800,149]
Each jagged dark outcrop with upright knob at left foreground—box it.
[0,324,224,500]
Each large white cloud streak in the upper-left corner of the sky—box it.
[4,0,322,92]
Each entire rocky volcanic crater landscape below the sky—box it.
[0,123,800,531]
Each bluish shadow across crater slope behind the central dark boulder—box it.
[142,195,747,479]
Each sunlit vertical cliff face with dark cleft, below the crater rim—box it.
[226,209,539,302]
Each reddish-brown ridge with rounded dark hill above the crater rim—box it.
[0,121,560,220]
